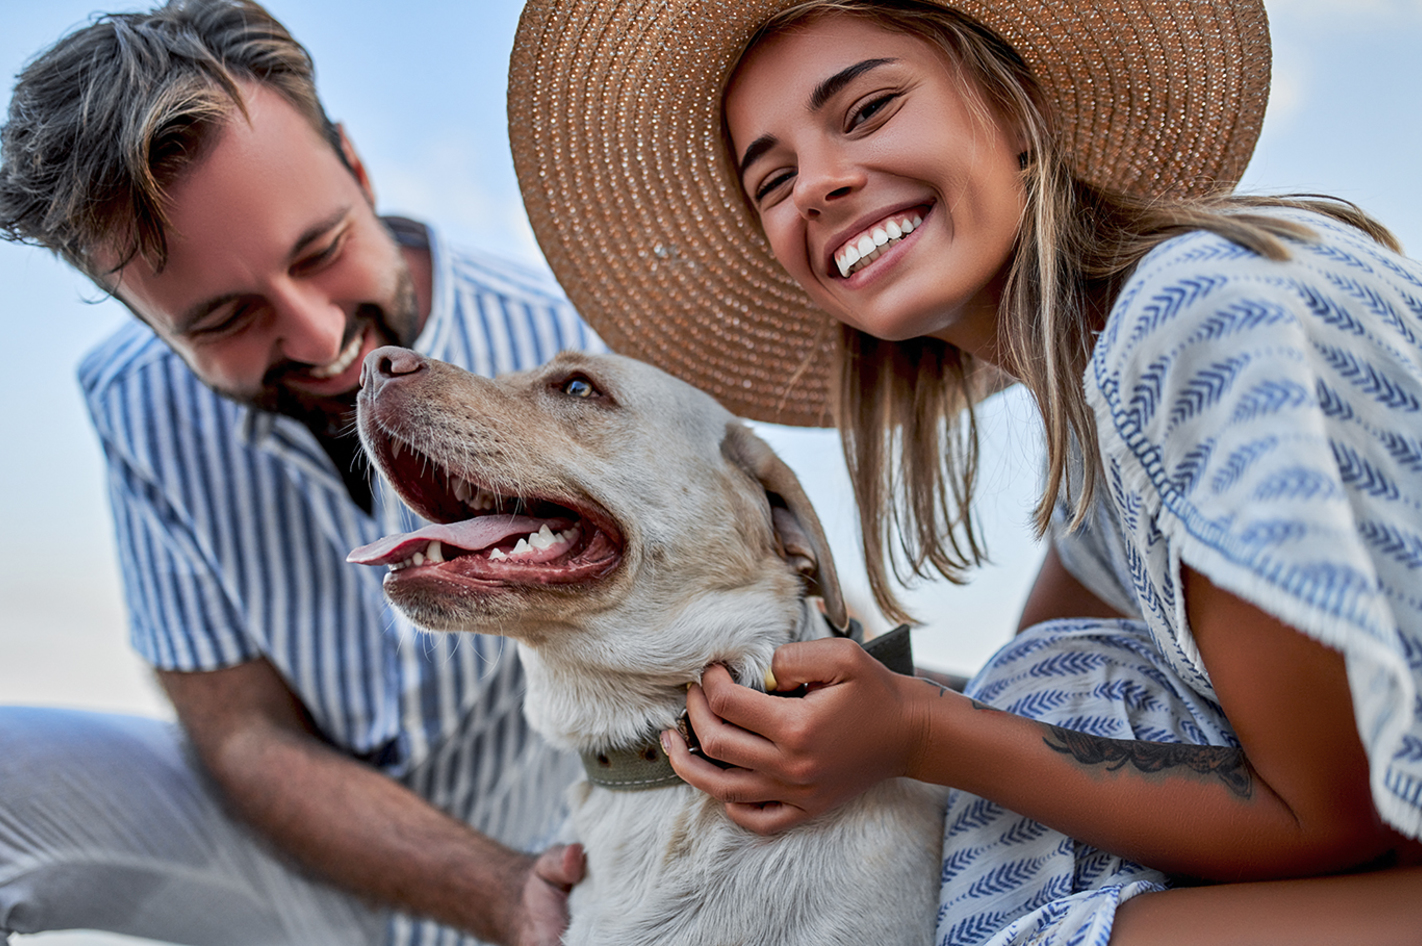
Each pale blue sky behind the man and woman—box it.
[0,0,1422,714]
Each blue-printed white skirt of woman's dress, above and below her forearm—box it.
[937,620,1237,946]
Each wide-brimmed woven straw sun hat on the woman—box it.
[509,0,1270,427]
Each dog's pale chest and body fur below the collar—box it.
[565,780,943,946]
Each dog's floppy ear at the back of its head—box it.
[721,421,849,629]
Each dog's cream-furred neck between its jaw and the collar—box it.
[519,599,826,753]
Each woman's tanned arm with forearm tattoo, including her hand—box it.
[668,560,1402,879]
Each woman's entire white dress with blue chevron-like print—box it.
[937,212,1422,946]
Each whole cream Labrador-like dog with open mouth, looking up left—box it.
[351,349,944,946]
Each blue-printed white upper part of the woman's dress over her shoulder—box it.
[1085,211,1422,838]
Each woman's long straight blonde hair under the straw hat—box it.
[747,0,1398,620]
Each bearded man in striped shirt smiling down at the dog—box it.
[0,0,600,945]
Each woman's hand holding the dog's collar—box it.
[661,640,941,834]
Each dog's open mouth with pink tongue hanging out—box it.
[346,431,623,585]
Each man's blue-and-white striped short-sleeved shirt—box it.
[80,223,603,943]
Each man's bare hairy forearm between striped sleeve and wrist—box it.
[159,660,533,942]
